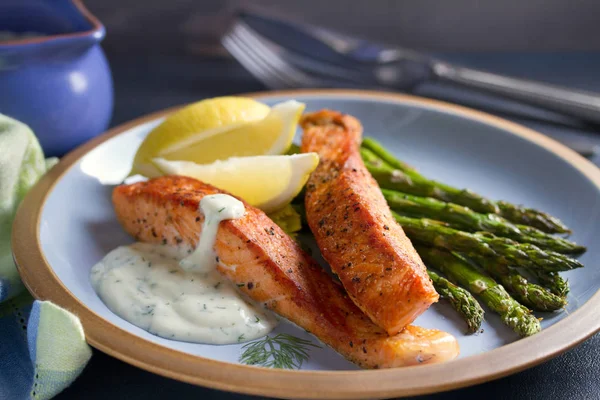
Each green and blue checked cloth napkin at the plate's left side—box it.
[0,114,92,400]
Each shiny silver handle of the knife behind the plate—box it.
[432,61,600,124]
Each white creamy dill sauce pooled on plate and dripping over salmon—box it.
[90,194,277,344]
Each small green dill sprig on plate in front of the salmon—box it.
[240,333,321,369]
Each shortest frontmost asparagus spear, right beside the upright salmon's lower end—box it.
[427,270,483,333]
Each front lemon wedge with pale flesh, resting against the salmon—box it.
[153,153,319,213]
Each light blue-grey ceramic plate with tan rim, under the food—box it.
[13,91,600,398]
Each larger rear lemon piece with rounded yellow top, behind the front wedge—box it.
[131,97,304,177]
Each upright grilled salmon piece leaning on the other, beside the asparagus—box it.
[300,110,438,335]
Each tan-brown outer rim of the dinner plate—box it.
[12,90,600,399]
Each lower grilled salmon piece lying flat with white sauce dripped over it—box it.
[113,176,458,368]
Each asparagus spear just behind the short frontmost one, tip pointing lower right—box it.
[417,246,541,336]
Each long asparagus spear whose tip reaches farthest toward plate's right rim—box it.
[381,189,586,254]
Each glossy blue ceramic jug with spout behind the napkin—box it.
[0,0,113,156]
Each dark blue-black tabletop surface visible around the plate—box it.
[56,35,600,400]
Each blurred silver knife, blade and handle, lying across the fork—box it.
[238,11,600,124]
